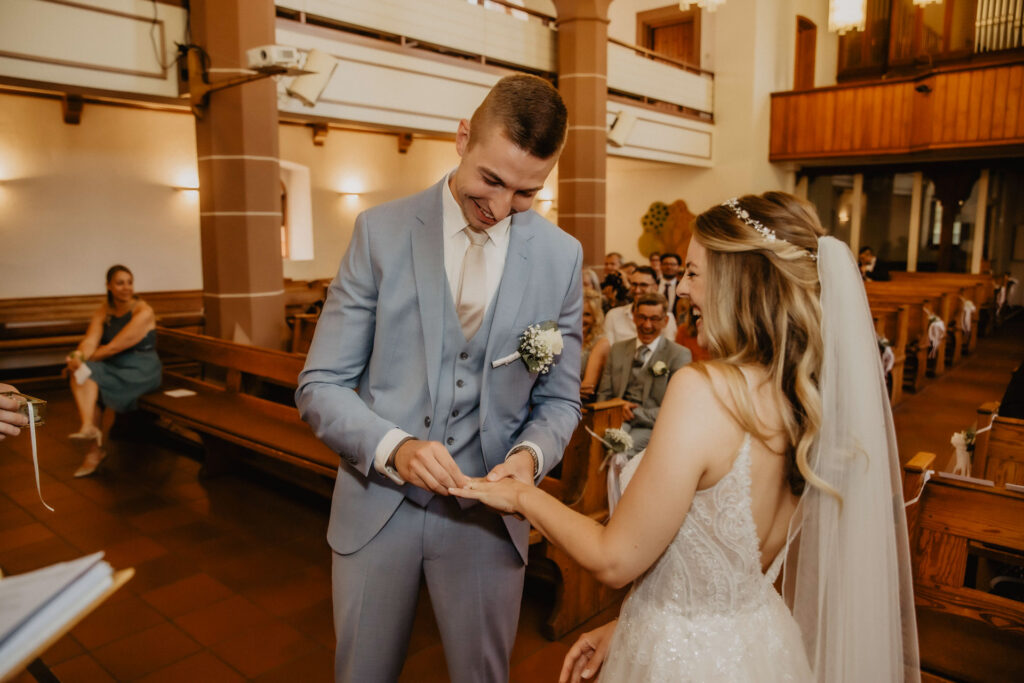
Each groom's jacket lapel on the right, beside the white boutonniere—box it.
[480,214,544,424]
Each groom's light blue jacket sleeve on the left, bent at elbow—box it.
[295,213,396,475]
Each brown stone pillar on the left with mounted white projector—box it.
[189,0,287,348]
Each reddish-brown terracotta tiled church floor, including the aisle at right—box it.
[0,321,1024,683]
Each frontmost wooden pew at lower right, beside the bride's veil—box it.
[904,453,1024,682]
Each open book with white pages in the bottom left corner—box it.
[0,552,114,681]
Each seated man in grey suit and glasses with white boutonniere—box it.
[597,294,691,453]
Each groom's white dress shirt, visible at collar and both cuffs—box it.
[374,176,544,484]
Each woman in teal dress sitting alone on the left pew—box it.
[67,265,161,477]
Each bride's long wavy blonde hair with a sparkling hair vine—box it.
[693,191,833,495]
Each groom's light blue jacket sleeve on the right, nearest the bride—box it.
[515,243,583,480]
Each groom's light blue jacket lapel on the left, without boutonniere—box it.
[412,180,447,402]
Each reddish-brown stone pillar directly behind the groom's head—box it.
[554,0,611,265]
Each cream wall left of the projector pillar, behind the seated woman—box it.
[0,94,202,298]
